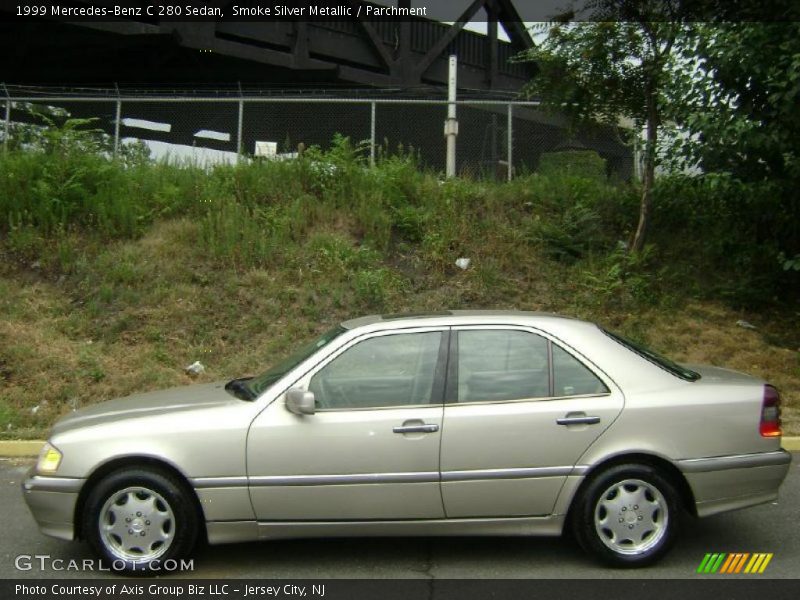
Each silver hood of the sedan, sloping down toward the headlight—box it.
[53,381,234,434]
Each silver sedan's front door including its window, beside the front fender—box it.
[247,328,447,521]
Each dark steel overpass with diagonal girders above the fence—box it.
[0,0,533,92]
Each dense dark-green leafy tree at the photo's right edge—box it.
[672,18,800,272]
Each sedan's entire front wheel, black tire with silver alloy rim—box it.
[82,468,200,572]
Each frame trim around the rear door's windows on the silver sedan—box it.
[444,325,616,406]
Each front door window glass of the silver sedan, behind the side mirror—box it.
[308,331,442,410]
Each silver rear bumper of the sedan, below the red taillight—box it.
[678,450,792,517]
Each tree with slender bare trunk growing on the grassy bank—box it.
[522,0,683,252]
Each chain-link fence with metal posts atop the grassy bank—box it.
[0,89,633,180]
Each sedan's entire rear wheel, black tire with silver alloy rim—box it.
[572,464,680,568]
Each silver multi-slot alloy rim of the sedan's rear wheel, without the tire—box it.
[594,479,669,556]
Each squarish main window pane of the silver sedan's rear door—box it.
[458,329,550,402]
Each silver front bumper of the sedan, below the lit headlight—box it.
[22,468,85,540]
